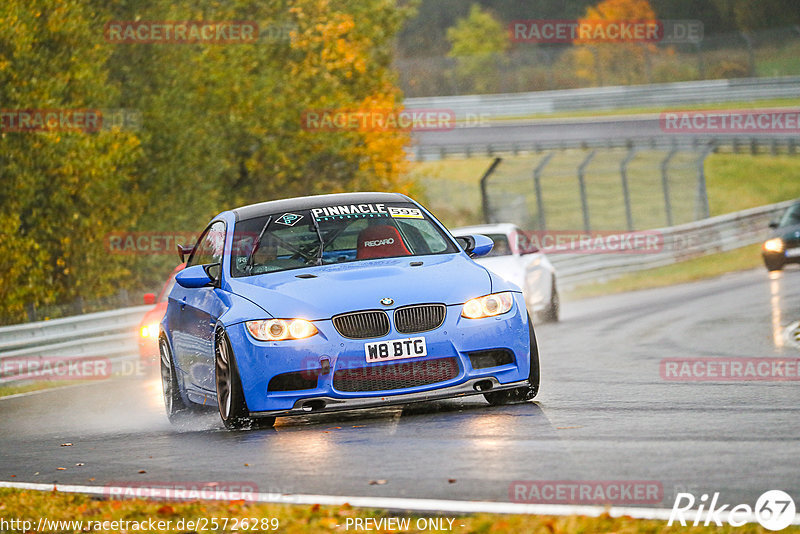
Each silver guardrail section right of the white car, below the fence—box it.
[548,200,795,287]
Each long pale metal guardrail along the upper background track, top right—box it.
[405,76,800,120]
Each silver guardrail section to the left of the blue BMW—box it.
[0,306,152,384]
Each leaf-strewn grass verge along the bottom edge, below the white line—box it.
[0,489,800,534]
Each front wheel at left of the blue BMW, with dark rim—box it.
[214,330,275,430]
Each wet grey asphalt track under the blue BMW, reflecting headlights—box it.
[0,268,800,507]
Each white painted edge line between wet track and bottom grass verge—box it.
[0,481,800,525]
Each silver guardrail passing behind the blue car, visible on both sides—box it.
[0,201,794,384]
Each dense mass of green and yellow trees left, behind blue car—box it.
[0,0,410,321]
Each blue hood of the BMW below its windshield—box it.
[229,254,492,320]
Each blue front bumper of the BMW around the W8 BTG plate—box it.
[227,293,530,417]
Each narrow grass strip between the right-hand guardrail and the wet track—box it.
[564,244,763,300]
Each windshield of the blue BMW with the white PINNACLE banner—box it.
[231,202,457,277]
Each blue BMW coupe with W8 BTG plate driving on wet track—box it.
[159,193,539,429]
